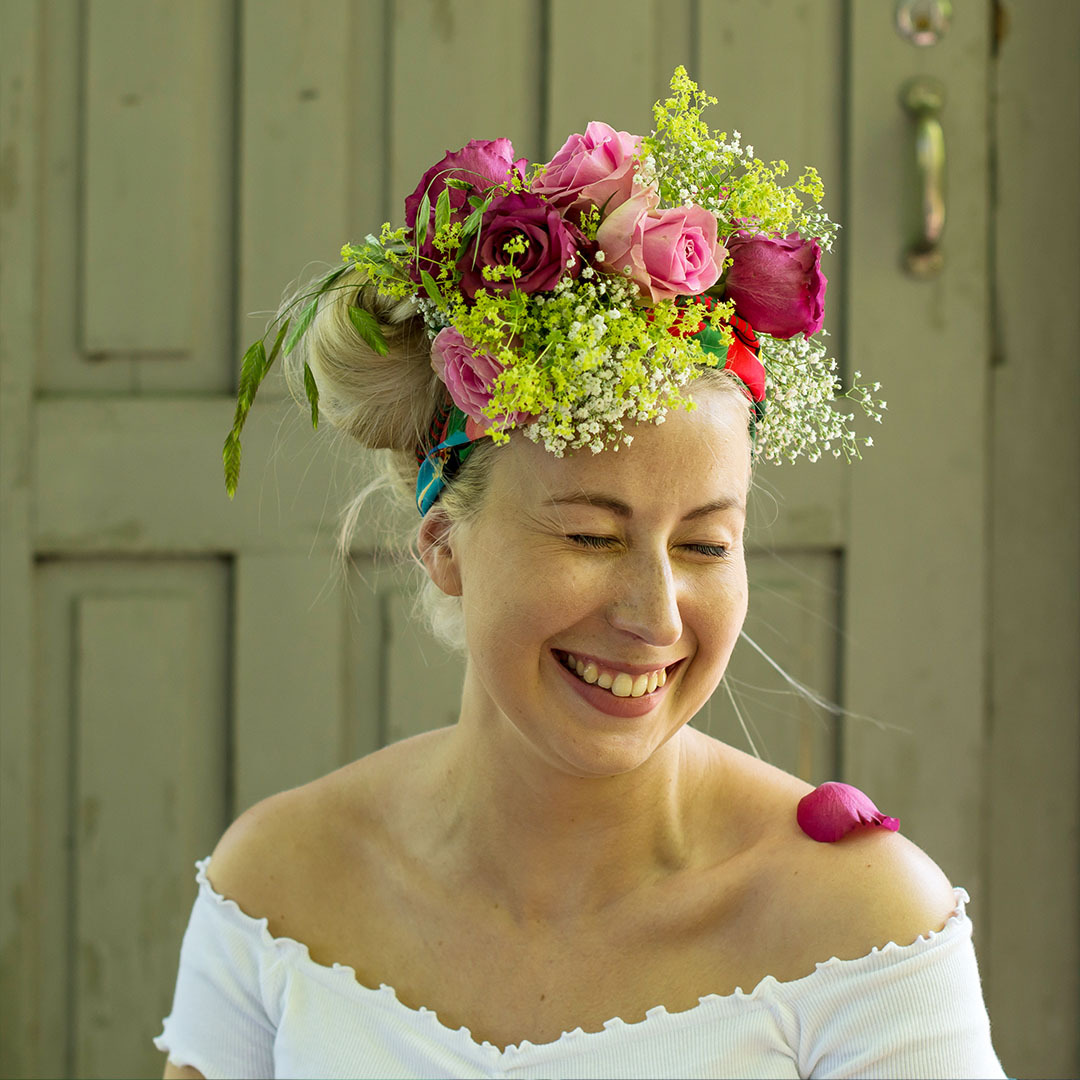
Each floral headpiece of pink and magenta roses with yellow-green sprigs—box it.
[224,67,886,513]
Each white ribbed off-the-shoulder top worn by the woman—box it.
[153,859,1004,1080]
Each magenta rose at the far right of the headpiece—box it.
[724,232,828,339]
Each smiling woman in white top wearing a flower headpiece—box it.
[157,70,1003,1077]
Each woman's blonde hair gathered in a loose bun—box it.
[281,270,750,652]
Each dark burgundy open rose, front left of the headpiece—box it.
[458,192,584,299]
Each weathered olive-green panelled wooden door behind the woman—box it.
[0,0,1080,1077]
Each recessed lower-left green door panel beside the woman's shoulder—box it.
[33,558,229,1077]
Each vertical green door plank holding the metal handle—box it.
[843,3,989,885]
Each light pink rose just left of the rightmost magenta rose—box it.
[596,189,727,303]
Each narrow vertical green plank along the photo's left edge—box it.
[0,0,42,1076]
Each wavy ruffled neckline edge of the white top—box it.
[195,855,971,1059]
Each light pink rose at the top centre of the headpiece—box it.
[532,120,642,221]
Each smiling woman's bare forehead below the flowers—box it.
[490,389,750,510]
